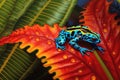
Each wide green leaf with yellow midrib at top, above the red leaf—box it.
[16,0,76,28]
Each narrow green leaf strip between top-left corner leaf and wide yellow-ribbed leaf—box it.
[0,0,33,37]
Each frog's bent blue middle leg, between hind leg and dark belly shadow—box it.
[69,37,91,55]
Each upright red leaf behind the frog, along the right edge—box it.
[80,0,120,80]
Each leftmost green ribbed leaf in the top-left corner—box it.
[0,0,16,33]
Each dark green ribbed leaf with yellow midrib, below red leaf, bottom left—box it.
[0,45,35,80]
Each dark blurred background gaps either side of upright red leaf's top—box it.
[66,0,120,26]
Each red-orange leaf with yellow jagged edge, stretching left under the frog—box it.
[0,24,113,80]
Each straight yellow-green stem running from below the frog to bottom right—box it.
[94,51,113,80]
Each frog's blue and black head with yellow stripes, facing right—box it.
[81,26,101,44]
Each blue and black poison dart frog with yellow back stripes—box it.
[55,26,104,55]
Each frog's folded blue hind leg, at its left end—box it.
[55,30,66,50]
